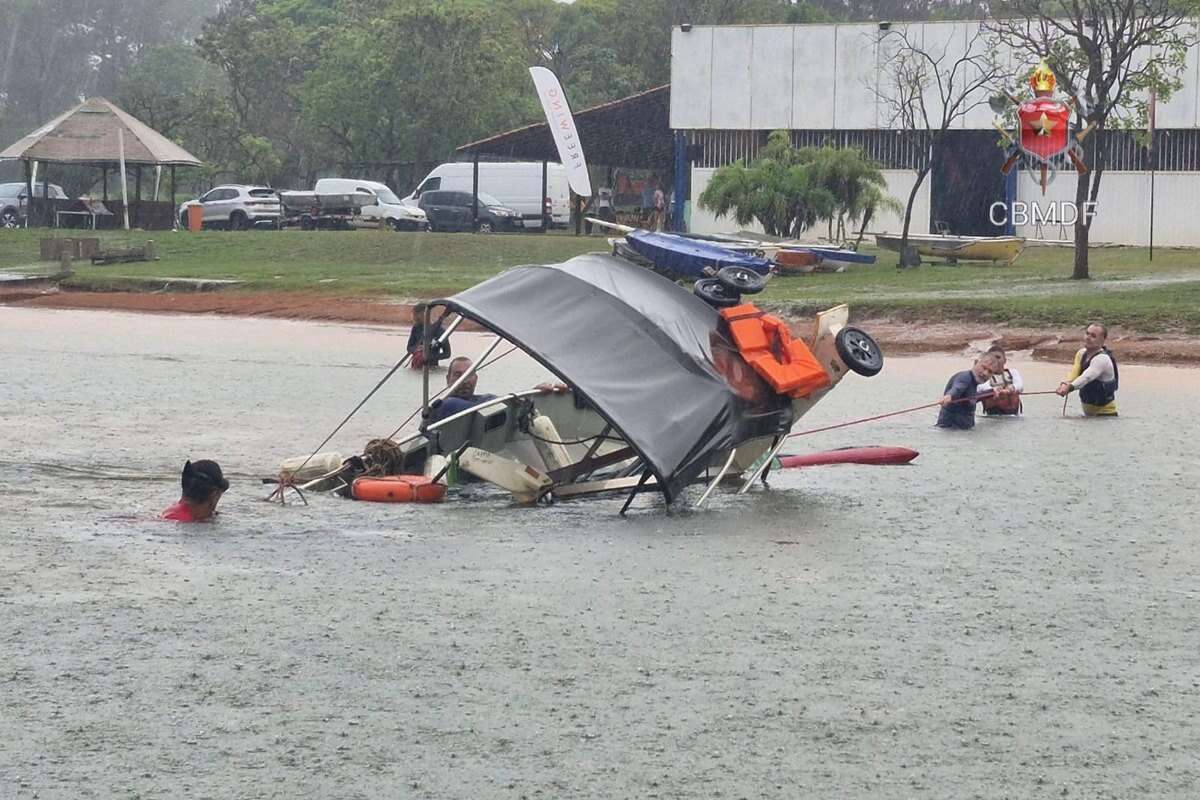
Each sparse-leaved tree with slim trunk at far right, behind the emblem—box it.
[988,0,1200,278]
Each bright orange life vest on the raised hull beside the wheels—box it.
[720,302,829,398]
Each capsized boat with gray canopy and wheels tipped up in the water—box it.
[290,253,883,511]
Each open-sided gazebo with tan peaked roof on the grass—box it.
[0,97,202,227]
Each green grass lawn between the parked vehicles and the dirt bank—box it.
[7,230,1200,332]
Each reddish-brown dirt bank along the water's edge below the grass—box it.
[7,290,1200,366]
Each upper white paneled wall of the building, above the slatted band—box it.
[671,22,1200,131]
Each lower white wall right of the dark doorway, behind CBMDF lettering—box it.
[1016,172,1200,247]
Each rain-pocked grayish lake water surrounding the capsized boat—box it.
[0,307,1200,799]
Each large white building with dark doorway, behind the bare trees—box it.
[671,22,1200,246]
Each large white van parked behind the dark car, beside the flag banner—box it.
[403,161,571,228]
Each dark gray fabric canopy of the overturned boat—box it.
[431,253,791,501]
